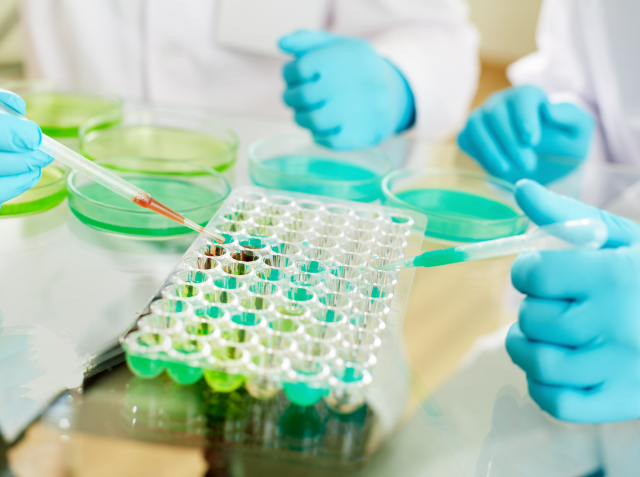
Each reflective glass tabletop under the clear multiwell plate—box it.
[0,124,640,477]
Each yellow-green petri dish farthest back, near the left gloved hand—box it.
[3,81,122,138]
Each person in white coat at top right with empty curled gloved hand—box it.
[459,0,640,182]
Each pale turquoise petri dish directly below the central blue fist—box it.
[248,134,393,202]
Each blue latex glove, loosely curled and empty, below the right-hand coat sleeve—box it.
[458,86,595,184]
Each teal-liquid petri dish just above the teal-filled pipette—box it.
[382,168,529,242]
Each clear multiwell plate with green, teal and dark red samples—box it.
[121,188,425,414]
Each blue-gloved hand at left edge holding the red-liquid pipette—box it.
[0,89,53,206]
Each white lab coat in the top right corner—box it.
[508,0,640,165]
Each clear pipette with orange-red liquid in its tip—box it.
[0,103,224,243]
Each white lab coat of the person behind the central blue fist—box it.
[22,0,478,139]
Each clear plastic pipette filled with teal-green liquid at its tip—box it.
[378,219,609,271]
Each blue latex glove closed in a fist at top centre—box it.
[279,30,415,149]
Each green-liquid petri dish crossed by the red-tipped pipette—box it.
[68,158,231,240]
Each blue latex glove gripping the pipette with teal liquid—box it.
[507,180,640,423]
